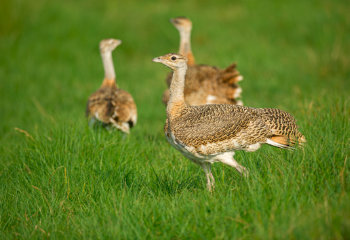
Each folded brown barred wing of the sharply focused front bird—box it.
[171,104,264,146]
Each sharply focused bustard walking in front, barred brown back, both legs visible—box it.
[153,53,306,191]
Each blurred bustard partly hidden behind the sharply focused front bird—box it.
[162,17,243,105]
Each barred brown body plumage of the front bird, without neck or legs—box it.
[165,104,303,155]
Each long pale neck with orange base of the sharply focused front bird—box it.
[167,66,187,119]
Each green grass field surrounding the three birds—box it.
[0,0,350,239]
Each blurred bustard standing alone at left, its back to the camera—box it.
[86,38,137,134]
